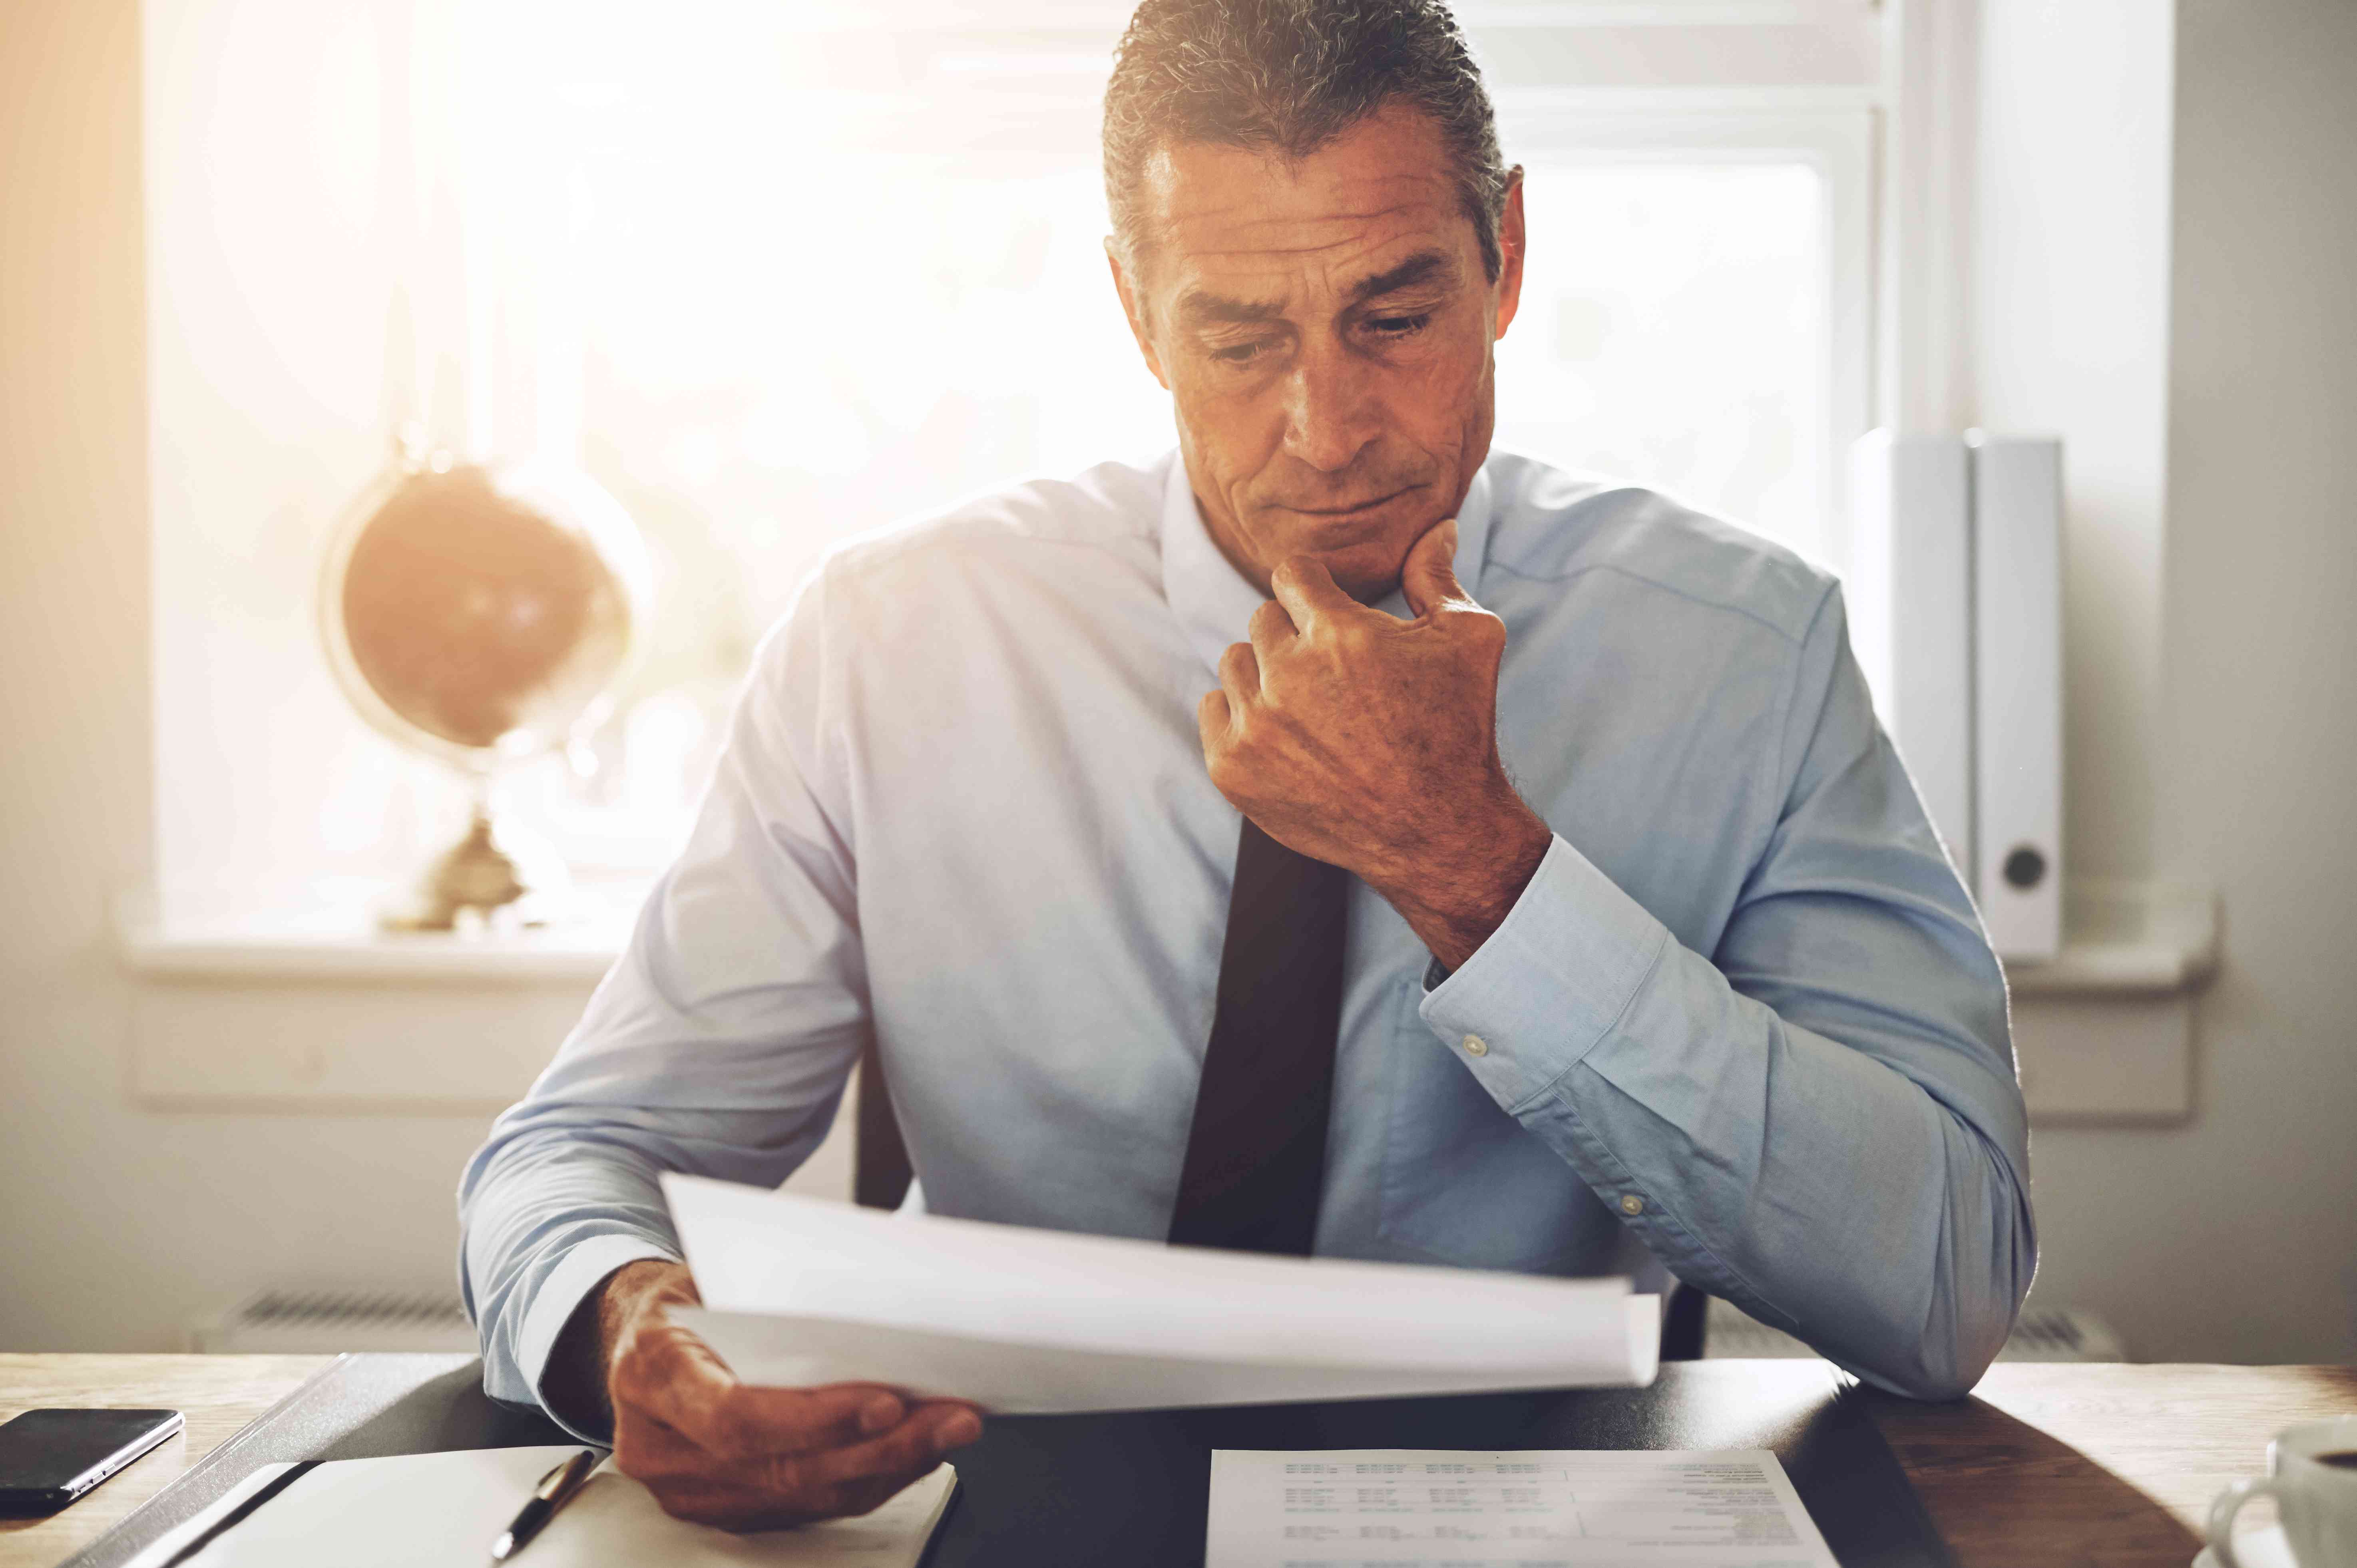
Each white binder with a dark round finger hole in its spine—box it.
[1966,432,2062,960]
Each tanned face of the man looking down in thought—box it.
[1113,106,1523,601]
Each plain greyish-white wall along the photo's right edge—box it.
[2032,0,2357,1361]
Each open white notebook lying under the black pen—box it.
[132,1443,957,1568]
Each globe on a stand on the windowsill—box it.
[321,455,648,931]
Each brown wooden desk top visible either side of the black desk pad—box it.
[0,1356,2357,1568]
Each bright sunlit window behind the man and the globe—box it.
[146,0,1876,917]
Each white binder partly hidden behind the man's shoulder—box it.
[1850,429,1973,868]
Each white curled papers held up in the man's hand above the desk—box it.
[662,1174,1662,1413]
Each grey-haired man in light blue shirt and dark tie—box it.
[462,0,2034,1526]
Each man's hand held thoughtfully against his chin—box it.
[1197,519,1551,969]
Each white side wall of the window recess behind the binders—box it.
[1954,0,2173,877]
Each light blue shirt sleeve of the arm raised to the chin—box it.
[1421,577,2036,1398]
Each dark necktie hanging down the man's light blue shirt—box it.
[1171,818,1351,1257]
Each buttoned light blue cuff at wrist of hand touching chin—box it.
[1419,835,1671,1113]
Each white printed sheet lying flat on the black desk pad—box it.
[1204,1448,1836,1568]
